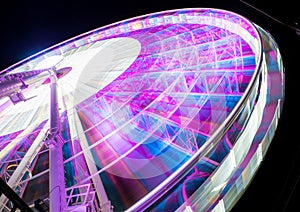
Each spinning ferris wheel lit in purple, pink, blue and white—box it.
[0,8,284,211]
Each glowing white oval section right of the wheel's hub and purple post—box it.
[59,38,141,108]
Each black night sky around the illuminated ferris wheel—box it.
[0,0,300,212]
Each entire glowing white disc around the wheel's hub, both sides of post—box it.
[0,38,141,136]
